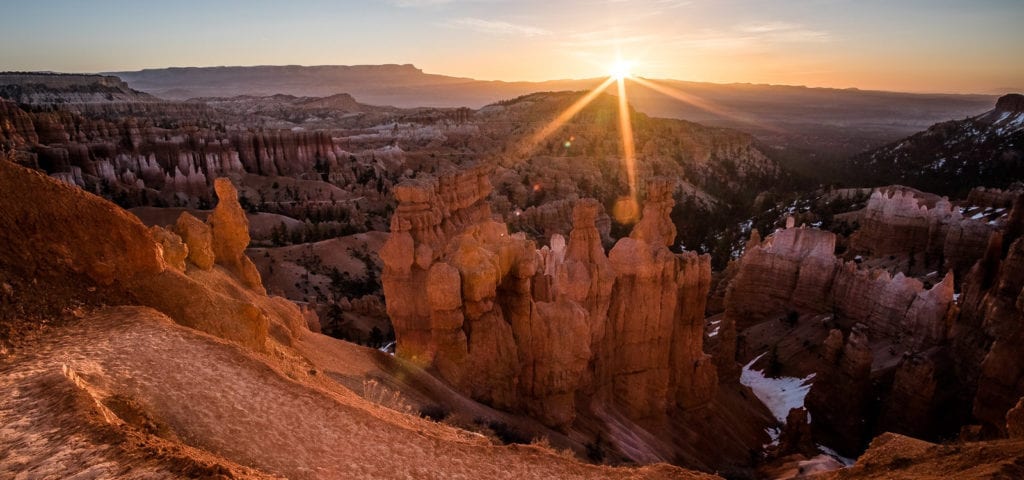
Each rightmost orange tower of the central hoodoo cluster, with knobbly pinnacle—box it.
[598,182,718,417]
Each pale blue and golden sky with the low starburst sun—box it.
[0,0,1024,92]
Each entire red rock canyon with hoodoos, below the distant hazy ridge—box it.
[0,74,1024,478]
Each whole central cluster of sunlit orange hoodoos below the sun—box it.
[380,168,717,427]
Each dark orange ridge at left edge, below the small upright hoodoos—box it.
[0,161,304,350]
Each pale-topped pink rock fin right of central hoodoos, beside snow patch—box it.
[716,223,957,454]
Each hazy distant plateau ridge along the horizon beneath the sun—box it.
[113,64,996,173]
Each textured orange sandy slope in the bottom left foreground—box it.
[0,307,714,479]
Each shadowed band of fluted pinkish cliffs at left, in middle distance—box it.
[0,99,348,204]
